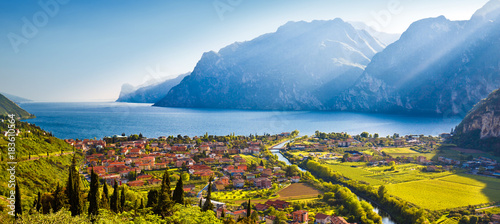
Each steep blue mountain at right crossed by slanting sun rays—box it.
[329,0,500,116]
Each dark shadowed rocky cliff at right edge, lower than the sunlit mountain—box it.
[453,89,500,155]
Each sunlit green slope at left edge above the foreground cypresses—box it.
[0,121,81,211]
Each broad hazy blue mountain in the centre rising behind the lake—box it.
[155,19,385,110]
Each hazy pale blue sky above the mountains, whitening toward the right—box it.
[0,0,487,101]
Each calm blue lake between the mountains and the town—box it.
[21,102,461,139]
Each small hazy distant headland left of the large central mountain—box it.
[116,73,189,103]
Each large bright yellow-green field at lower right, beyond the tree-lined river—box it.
[386,175,500,210]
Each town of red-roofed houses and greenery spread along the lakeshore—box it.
[61,131,500,223]
